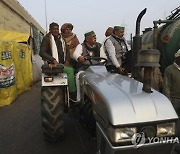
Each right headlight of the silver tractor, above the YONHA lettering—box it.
[157,122,176,137]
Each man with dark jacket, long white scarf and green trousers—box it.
[39,22,76,96]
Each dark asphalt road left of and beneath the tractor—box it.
[0,82,96,154]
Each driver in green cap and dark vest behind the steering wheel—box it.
[73,31,103,101]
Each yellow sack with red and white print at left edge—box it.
[0,41,17,107]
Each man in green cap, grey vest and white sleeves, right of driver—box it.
[104,26,130,74]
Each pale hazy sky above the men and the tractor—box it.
[17,0,180,42]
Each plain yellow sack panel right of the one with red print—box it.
[13,43,33,94]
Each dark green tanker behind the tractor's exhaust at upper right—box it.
[142,6,180,72]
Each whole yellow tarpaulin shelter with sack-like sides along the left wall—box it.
[0,30,33,106]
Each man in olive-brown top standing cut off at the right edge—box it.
[163,49,180,137]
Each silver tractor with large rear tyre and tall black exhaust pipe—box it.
[41,7,179,154]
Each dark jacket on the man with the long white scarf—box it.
[39,33,70,64]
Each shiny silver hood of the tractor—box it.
[82,66,178,125]
